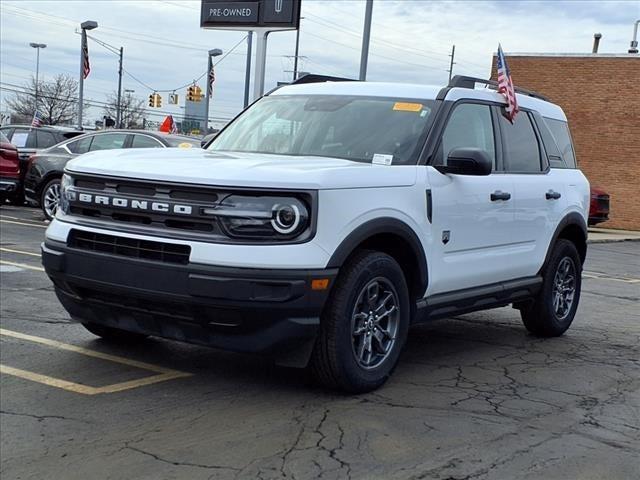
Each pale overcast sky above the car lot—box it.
[0,0,640,127]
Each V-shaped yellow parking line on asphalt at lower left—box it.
[0,328,191,395]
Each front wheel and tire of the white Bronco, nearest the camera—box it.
[310,250,410,393]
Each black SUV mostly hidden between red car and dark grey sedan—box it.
[0,125,84,204]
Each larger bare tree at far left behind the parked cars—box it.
[7,74,78,125]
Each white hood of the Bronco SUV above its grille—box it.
[66,148,416,190]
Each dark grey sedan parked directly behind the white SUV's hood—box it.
[24,130,200,219]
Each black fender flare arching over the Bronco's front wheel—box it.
[327,217,428,293]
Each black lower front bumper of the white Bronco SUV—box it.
[42,239,337,364]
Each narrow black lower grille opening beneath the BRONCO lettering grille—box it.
[67,229,191,265]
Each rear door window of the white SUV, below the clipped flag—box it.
[500,112,542,173]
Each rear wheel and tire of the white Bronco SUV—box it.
[520,239,582,337]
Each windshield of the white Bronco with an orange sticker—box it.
[208,95,434,165]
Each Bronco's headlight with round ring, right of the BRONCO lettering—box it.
[203,195,309,240]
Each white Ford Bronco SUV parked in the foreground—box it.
[42,77,589,392]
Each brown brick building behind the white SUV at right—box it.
[492,54,640,230]
